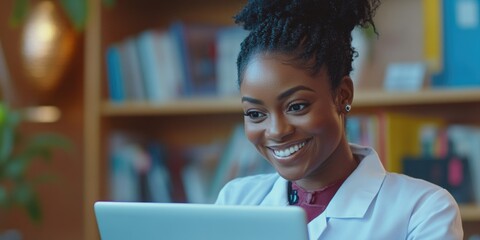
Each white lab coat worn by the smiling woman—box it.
[216,144,463,240]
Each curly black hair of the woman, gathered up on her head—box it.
[234,0,380,89]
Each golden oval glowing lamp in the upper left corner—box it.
[21,1,75,92]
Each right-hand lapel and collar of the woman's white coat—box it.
[322,144,386,218]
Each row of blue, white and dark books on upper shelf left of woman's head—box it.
[106,22,246,103]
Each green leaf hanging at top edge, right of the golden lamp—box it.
[60,0,88,31]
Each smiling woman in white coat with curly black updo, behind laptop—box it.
[217,0,463,239]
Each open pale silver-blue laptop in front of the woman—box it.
[94,202,308,240]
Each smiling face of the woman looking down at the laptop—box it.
[240,54,351,181]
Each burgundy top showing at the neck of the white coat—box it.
[292,179,345,222]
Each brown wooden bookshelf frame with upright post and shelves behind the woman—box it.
[83,0,480,239]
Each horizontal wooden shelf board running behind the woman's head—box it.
[101,88,480,117]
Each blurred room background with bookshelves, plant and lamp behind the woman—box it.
[0,0,480,240]
